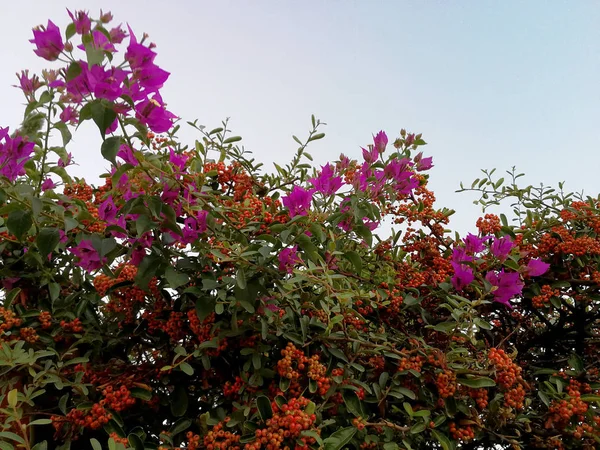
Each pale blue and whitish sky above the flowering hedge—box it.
[0,0,600,234]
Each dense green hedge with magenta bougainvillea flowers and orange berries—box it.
[0,11,600,450]
